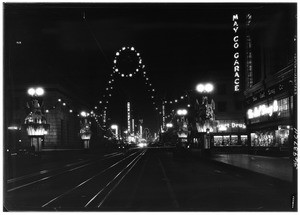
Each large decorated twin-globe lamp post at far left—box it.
[23,87,50,152]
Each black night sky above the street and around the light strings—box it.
[4,3,292,132]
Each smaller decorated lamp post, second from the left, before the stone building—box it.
[79,111,92,149]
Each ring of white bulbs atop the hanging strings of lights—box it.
[113,47,145,78]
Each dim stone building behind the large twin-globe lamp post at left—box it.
[5,85,92,151]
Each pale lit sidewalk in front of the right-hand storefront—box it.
[211,154,293,182]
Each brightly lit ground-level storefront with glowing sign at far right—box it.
[247,80,294,155]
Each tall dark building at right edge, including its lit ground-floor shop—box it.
[244,3,297,155]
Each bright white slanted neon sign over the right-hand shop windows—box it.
[247,100,278,119]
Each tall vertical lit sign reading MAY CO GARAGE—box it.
[232,14,240,92]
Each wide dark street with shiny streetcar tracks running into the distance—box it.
[4,148,293,211]
